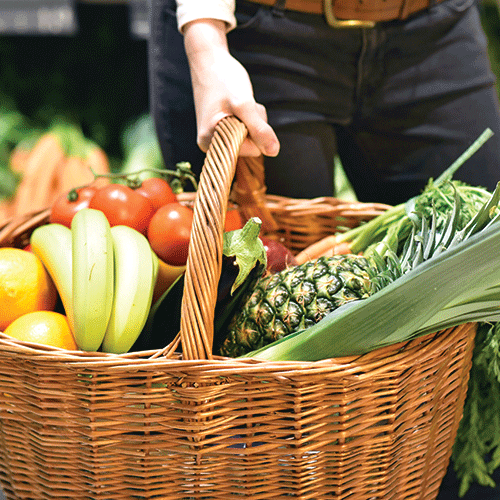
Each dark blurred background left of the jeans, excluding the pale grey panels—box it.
[0,3,149,156]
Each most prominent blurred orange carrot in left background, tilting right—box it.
[14,132,64,215]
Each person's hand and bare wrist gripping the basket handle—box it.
[184,19,279,156]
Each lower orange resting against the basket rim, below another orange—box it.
[4,311,78,351]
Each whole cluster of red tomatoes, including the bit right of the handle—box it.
[49,167,243,266]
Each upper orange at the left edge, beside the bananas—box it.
[0,247,57,331]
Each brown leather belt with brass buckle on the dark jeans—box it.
[247,0,443,28]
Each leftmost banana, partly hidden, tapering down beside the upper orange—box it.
[30,224,73,330]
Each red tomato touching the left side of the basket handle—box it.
[147,203,193,266]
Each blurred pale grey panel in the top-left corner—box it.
[0,0,77,35]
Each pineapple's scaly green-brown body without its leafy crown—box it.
[220,255,377,357]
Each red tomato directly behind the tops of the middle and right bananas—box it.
[89,184,155,235]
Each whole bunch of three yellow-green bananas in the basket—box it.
[30,208,158,354]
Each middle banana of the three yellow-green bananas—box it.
[71,208,114,351]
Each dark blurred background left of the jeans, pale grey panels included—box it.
[0,0,149,162]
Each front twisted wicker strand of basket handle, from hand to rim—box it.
[180,116,247,359]
